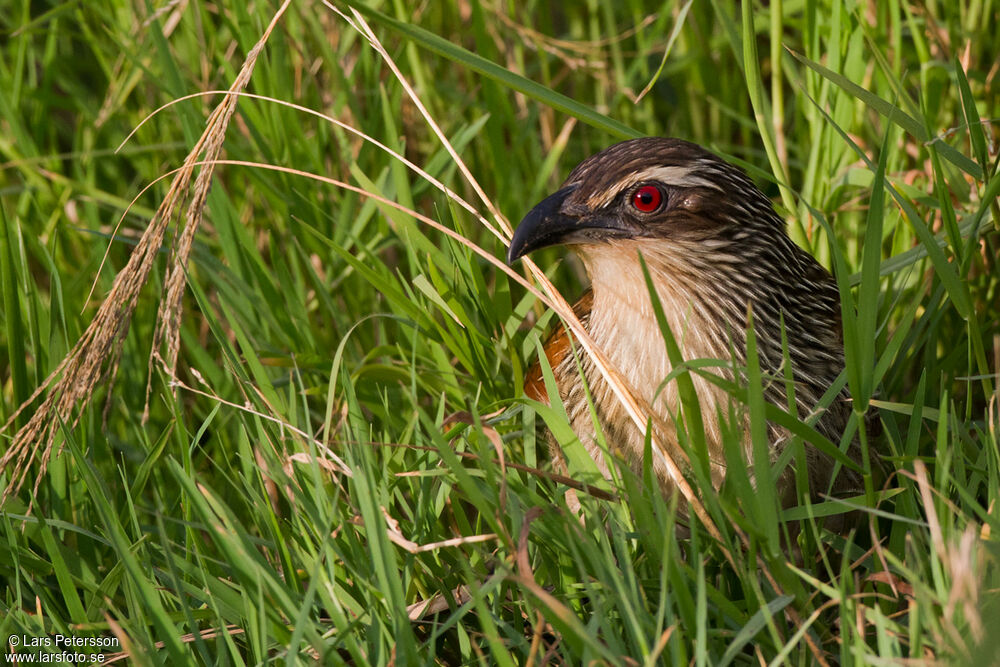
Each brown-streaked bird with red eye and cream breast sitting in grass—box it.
[507,137,864,507]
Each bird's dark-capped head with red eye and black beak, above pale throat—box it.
[507,137,784,263]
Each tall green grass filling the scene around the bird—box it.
[0,0,1000,665]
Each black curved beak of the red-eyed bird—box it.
[507,183,626,264]
